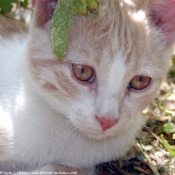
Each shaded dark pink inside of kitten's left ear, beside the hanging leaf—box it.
[32,0,58,27]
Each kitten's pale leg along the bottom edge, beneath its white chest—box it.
[34,165,95,175]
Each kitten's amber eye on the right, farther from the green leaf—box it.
[129,75,151,90]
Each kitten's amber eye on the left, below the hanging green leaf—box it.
[72,64,93,82]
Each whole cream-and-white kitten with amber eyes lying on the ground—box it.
[0,0,175,175]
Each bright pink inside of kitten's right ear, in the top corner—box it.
[150,0,175,44]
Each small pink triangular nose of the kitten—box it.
[96,116,118,131]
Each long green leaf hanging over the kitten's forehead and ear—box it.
[51,0,98,60]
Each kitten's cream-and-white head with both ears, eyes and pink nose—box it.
[29,0,175,139]
